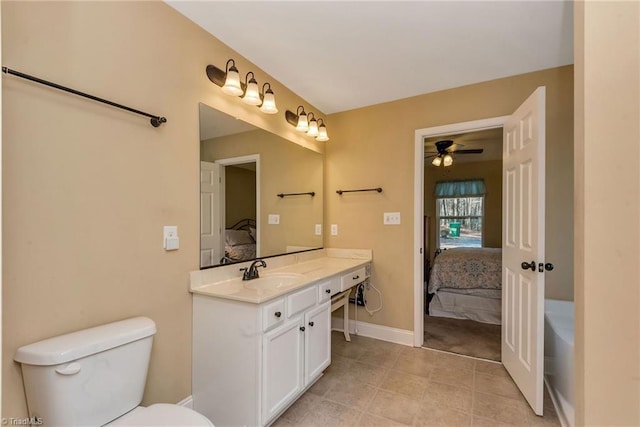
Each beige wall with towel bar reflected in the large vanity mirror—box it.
[201,130,324,256]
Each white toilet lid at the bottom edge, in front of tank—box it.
[108,403,213,427]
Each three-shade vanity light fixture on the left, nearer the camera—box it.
[207,59,278,114]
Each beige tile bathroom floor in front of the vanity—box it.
[273,332,560,427]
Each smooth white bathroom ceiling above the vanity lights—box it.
[167,0,573,114]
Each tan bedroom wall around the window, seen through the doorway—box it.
[424,160,502,259]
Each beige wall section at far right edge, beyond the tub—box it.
[575,2,640,426]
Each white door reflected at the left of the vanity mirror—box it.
[200,162,222,267]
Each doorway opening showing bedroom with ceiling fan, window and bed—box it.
[423,126,502,361]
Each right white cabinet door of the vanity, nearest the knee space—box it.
[304,301,331,385]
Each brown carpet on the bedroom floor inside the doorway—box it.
[422,315,502,361]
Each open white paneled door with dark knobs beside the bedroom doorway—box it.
[502,87,545,415]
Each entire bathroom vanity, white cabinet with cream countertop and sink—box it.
[191,249,371,426]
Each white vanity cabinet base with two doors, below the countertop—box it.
[193,282,331,426]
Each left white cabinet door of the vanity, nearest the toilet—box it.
[261,317,306,424]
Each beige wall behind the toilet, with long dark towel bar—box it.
[0,1,322,417]
